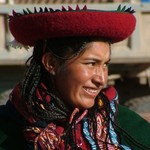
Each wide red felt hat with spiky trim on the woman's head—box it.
[9,5,136,46]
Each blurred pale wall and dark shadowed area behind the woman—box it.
[0,0,150,121]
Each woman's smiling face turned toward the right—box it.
[54,41,110,109]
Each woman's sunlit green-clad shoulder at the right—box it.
[117,105,150,150]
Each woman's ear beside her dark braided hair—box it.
[42,53,56,75]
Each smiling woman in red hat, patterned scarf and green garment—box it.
[0,6,150,150]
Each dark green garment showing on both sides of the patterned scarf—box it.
[0,105,150,150]
